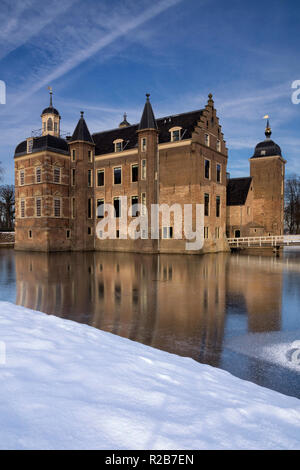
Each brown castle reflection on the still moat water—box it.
[15,252,282,366]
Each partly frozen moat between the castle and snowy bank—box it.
[0,249,300,398]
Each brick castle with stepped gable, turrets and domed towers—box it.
[15,91,286,253]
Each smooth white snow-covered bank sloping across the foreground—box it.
[0,302,300,449]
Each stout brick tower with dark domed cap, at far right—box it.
[250,119,286,235]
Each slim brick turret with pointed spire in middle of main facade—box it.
[137,93,159,250]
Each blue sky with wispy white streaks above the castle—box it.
[0,0,300,183]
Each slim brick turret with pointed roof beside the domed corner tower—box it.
[69,111,96,251]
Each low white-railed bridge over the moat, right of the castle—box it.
[227,235,300,249]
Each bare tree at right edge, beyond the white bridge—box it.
[284,176,300,234]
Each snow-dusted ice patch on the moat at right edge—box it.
[224,330,300,370]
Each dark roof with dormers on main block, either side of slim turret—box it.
[92,109,203,155]
